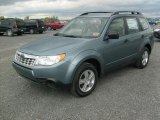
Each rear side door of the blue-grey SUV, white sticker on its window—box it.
[125,17,143,55]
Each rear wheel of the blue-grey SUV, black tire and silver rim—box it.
[135,47,150,69]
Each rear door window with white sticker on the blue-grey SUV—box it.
[126,18,139,34]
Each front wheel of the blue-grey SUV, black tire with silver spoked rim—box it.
[71,63,98,97]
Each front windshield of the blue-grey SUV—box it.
[56,17,108,38]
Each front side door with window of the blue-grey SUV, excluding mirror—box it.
[103,17,129,68]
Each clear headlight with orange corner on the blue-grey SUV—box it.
[35,54,66,65]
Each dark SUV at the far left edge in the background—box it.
[0,18,25,36]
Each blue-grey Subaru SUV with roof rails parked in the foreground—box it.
[13,11,154,97]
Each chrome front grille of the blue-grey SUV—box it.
[15,51,36,66]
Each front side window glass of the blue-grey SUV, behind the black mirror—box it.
[108,18,125,37]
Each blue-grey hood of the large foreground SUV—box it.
[19,36,90,55]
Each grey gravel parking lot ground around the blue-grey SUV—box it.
[0,31,160,120]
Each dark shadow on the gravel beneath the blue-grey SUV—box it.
[26,65,136,98]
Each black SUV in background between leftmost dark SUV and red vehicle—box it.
[25,19,45,34]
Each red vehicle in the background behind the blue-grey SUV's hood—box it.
[46,22,65,30]
